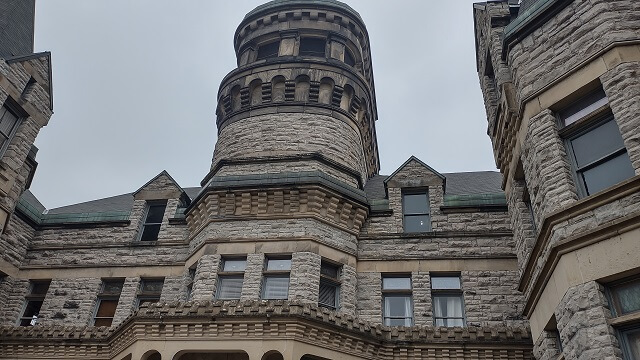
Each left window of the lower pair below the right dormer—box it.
[382,276,413,326]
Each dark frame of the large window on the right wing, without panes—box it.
[555,87,635,198]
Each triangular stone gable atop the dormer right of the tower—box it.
[385,156,445,188]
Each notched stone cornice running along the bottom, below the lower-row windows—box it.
[0,300,533,360]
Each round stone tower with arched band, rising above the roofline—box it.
[205,0,379,189]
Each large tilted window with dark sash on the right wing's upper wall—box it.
[559,89,635,196]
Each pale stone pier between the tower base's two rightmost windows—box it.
[289,252,321,304]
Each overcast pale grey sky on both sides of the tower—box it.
[31,0,495,208]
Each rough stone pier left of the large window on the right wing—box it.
[522,109,578,222]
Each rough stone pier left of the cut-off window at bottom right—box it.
[555,281,622,360]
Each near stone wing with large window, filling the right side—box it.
[474,0,640,359]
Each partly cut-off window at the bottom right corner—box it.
[607,277,640,360]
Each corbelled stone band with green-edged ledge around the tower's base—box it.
[187,171,368,238]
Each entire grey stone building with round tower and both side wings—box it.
[0,0,640,360]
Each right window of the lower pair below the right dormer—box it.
[431,276,465,326]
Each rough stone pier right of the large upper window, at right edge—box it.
[601,62,640,175]
